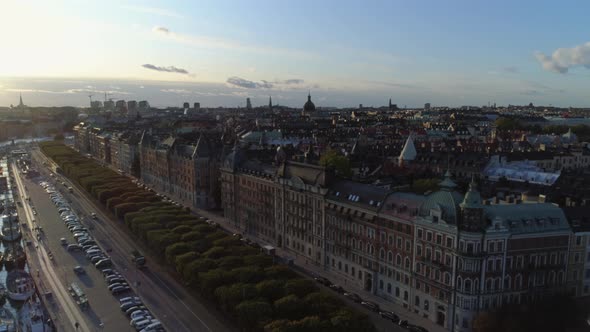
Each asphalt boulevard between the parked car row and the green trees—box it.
[32,150,236,332]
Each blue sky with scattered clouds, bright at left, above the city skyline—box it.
[0,0,590,107]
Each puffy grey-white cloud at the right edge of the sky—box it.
[535,42,590,74]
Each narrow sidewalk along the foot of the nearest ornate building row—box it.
[191,208,447,332]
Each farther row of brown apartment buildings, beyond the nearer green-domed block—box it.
[74,124,221,209]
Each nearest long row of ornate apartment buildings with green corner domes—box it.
[220,146,590,331]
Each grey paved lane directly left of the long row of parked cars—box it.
[25,175,132,331]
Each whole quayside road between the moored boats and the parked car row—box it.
[12,165,131,331]
